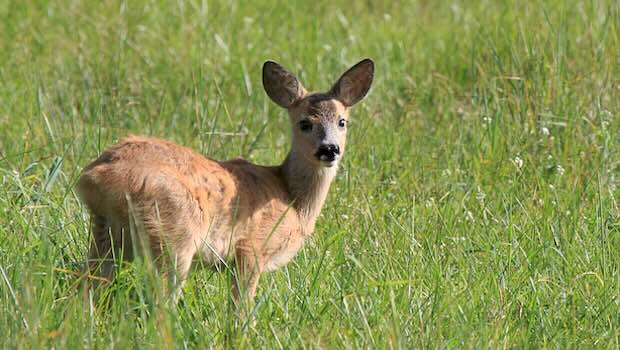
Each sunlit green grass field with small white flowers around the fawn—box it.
[0,0,620,349]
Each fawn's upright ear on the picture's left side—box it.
[263,61,306,108]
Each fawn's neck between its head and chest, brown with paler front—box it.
[282,149,337,235]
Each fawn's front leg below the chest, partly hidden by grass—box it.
[232,240,263,305]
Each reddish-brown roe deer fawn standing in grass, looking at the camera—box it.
[78,59,374,302]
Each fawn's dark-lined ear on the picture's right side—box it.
[330,58,375,107]
